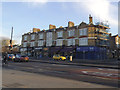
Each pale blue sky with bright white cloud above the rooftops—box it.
[0,0,118,44]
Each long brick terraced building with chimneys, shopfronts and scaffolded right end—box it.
[21,15,119,59]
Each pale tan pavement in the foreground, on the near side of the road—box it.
[2,68,114,88]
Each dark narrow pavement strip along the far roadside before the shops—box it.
[30,58,120,69]
